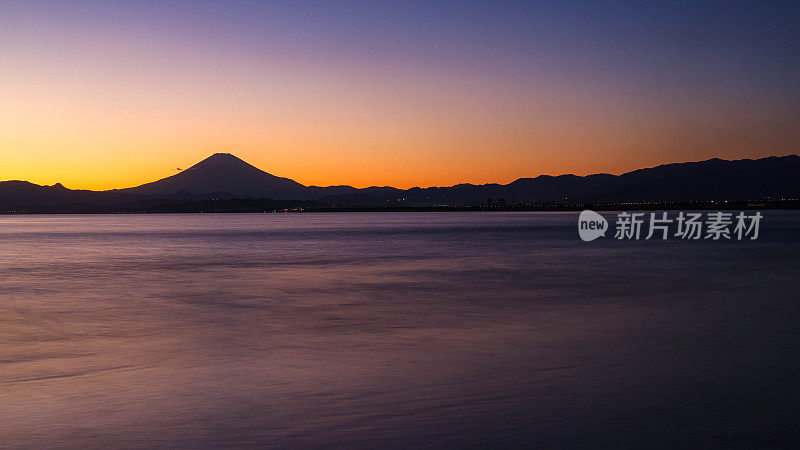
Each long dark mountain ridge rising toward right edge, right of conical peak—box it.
[320,155,800,206]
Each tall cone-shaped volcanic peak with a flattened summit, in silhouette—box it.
[119,153,306,199]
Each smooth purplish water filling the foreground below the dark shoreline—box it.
[0,211,800,448]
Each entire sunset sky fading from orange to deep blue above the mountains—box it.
[0,0,800,189]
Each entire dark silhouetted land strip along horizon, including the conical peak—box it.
[0,153,800,212]
